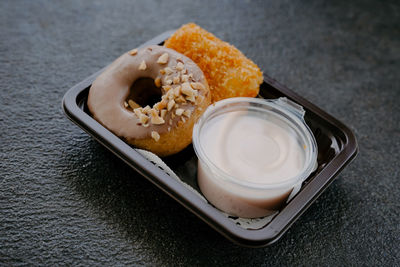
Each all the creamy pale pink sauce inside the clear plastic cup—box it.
[198,111,305,218]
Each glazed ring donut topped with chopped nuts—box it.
[87,45,210,156]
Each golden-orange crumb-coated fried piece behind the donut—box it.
[164,23,263,102]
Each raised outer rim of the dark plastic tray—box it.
[62,30,358,247]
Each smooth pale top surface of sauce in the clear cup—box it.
[200,111,305,184]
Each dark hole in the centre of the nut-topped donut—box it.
[126,78,162,107]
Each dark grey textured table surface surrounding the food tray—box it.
[0,0,400,266]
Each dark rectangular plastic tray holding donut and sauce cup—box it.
[63,31,358,247]
